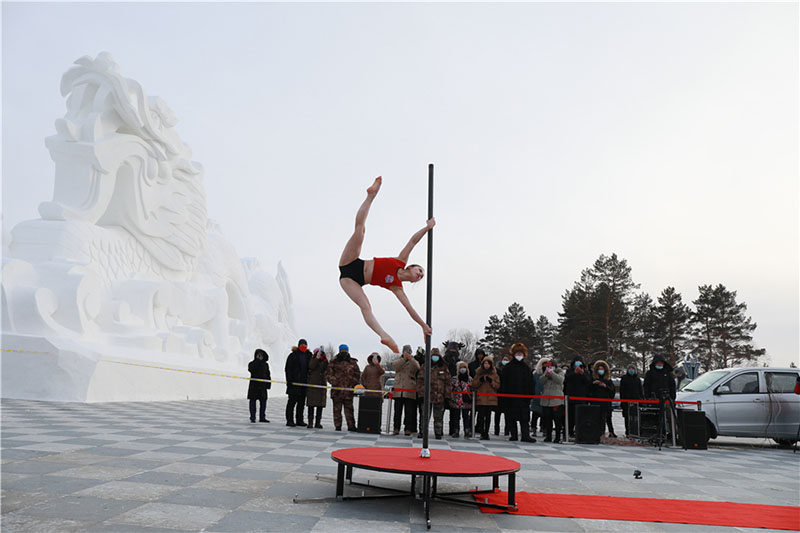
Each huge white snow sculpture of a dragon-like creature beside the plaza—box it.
[2,52,296,401]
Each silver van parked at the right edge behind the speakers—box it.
[677,367,800,446]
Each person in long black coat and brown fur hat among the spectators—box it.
[500,343,536,442]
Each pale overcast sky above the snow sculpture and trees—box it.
[2,2,800,365]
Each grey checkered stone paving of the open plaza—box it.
[2,395,800,533]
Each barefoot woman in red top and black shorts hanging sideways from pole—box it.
[339,176,436,353]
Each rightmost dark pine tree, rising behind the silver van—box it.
[692,284,766,370]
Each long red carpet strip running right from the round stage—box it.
[475,492,800,531]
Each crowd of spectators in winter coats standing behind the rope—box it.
[247,339,685,443]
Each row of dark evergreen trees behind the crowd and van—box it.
[479,254,766,372]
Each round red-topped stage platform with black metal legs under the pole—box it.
[331,447,520,528]
